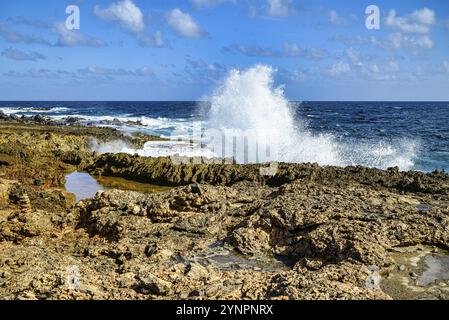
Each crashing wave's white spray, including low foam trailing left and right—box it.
[89,65,419,170]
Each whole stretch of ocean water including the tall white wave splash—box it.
[0,65,449,172]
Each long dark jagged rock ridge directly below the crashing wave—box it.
[85,154,449,195]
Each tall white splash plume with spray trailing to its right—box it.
[174,65,412,170]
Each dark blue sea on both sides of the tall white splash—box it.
[0,101,449,172]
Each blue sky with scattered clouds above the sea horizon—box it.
[0,0,449,101]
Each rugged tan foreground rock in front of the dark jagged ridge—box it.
[0,172,449,299]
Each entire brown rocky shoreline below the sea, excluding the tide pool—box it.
[0,117,449,299]
